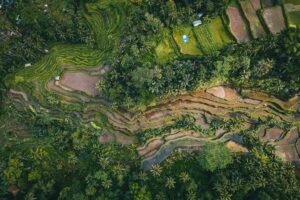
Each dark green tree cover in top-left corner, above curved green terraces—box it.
[0,0,94,99]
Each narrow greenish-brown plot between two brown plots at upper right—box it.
[240,1,265,38]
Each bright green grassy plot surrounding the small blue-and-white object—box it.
[173,27,203,56]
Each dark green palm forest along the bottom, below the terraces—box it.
[0,110,300,199]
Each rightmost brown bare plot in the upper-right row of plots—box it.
[263,6,286,34]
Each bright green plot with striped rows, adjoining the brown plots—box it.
[193,17,231,54]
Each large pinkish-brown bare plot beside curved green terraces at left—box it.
[60,72,99,96]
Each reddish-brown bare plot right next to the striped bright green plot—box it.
[227,6,251,43]
